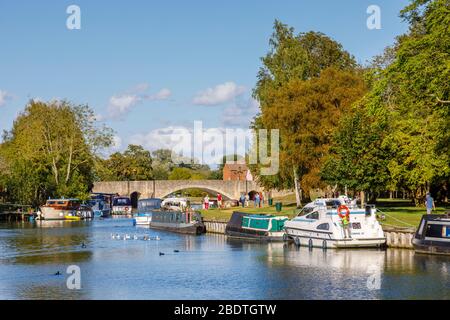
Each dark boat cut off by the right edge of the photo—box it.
[412,213,450,255]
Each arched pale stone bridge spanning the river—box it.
[93,180,288,199]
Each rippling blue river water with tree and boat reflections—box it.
[0,219,450,300]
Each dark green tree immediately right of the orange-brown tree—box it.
[320,101,391,202]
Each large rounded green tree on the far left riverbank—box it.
[0,101,112,204]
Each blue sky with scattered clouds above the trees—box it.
[0,0,408,155]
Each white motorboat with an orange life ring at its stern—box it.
[284,198,386,248]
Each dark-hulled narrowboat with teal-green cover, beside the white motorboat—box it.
[225,211,289,241]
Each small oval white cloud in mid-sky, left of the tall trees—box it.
[193,82,245,106]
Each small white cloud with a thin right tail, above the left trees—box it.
[108,83,172,118]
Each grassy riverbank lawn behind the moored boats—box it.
[201,197,450,228]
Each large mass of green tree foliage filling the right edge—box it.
[324,0,450,203]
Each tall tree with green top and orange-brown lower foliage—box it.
[250,21,366,206]
